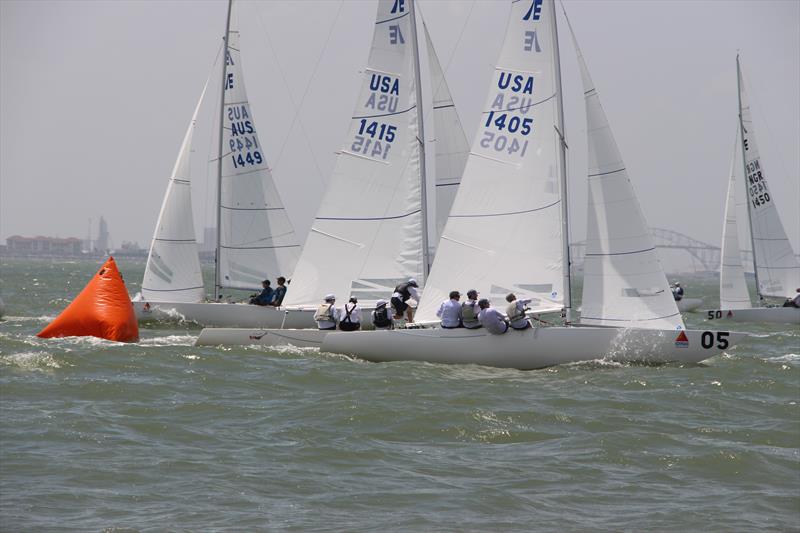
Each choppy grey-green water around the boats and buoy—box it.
[0,259,800,531]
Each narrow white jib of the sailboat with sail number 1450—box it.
[719,127,751,309]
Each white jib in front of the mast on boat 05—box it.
[570,19,684,329]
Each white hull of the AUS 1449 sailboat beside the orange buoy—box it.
[133,302,317,329]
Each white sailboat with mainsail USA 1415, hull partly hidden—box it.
[197,0,469,346]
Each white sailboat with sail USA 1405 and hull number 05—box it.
[321,0,744,369]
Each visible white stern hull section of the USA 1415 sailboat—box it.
[194,328,330,348]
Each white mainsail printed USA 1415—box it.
[284,0,424,308]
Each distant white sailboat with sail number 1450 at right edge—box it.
[707,55,800,325]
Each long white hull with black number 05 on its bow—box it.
[321,327,747,370]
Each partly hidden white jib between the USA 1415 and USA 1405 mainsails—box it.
[423,19,469,245]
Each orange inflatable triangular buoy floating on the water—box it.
[37,257,139,342]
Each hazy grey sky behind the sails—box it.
[0,0,800,252]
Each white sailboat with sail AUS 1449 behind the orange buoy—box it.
[134,0,306,327]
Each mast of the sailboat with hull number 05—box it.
[550,2,572,325]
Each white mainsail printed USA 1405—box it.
[415,1,564,322]
